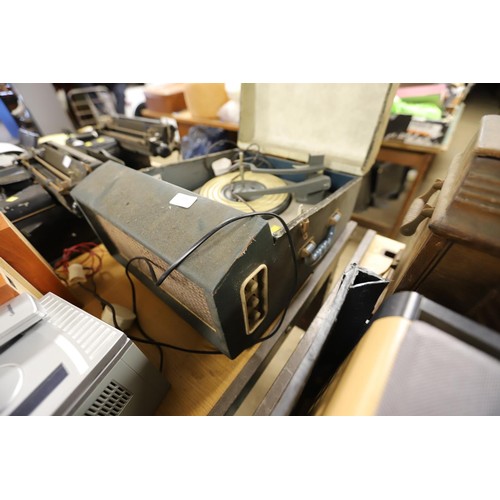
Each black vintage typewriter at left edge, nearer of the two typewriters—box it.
[0,141,101,262]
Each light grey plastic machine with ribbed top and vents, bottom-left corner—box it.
[0,293,169,416]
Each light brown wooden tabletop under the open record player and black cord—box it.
[71,222,356,416]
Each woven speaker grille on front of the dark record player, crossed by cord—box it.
[97,215,216,330]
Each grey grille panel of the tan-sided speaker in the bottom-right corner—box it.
[377,321,500,416]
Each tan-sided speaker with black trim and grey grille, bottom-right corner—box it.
[312,292,500,416]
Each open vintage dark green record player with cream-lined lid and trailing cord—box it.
[71,84,395,358]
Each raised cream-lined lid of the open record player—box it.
[238,83,397,175]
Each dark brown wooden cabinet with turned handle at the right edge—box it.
[389,115,500,330]
